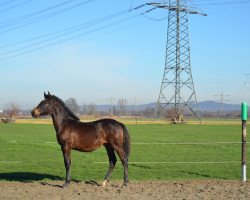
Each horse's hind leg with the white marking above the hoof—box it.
[102,144,117,186]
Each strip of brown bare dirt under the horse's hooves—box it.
[0,180,250,200]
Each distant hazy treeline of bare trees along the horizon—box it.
[0,98,241,118]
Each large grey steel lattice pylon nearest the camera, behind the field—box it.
[147,0,206,118]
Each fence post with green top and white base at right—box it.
[241,102,248,182]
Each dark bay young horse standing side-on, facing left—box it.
[31,92,130,187]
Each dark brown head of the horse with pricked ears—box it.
[31,92,53,118]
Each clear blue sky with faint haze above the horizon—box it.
[0,0,250,109]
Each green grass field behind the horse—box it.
[0,124,250,181]
